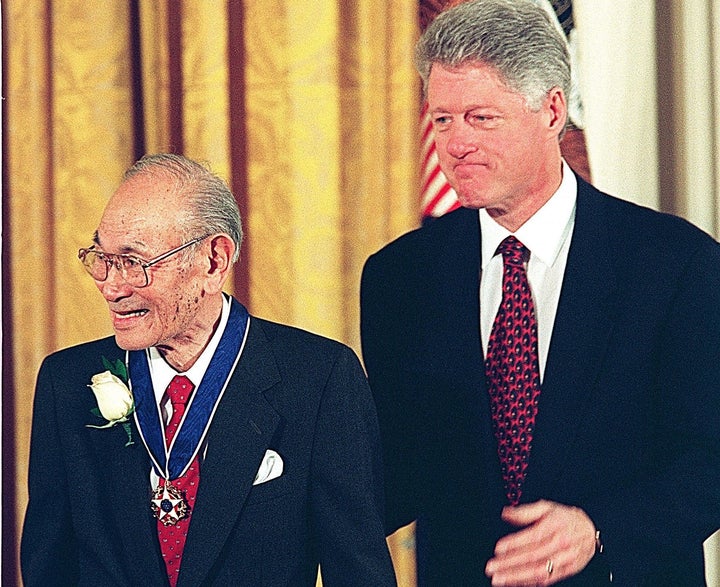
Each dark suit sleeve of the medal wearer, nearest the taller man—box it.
[311,347,396,587]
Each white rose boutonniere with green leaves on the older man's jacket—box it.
[87,357,135,446]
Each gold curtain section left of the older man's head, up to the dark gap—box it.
[3,0,132,584]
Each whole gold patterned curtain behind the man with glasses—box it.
[2,0,418,585]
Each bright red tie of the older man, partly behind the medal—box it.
[157,375,200,587]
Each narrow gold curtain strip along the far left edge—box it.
[3,1,55,582]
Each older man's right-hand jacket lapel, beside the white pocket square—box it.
[179,318,280,585]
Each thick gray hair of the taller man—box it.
[415,0,570,111]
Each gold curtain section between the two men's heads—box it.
[245,0,417,349]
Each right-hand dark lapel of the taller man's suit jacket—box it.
[525,180,616,495]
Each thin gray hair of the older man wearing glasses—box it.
[123,153,243,263]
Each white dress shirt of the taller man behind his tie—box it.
[479,161,577,381]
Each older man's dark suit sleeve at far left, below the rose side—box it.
[21,359,78,587]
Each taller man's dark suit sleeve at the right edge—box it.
[584,239,720,585]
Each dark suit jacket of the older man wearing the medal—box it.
[22,310,395,587]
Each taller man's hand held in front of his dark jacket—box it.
[485,500,595,587]
